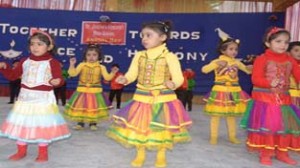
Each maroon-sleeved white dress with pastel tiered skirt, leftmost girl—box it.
[0,54,71,143]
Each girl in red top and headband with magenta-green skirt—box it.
[241,27,300,165]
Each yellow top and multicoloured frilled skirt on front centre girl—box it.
[107,44,192,150]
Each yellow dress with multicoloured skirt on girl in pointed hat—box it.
[202,55,251,117]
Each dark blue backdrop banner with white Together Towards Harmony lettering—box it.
[0,8,285,94]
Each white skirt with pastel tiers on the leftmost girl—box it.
[0,88,71,143]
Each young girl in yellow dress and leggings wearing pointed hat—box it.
[202,31,251,145]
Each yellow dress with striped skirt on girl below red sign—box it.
[64,61,114,123]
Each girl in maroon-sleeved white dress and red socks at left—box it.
[0,30,70,162]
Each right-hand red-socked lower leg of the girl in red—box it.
[276,135,297,165]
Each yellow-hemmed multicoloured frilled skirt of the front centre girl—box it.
[107,90,192,150]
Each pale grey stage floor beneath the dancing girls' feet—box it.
[0,97,300,168]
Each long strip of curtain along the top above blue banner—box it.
[0,0,272,13]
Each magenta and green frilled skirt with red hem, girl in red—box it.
[241,88,300,151]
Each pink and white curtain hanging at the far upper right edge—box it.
[285,2,300,41]
